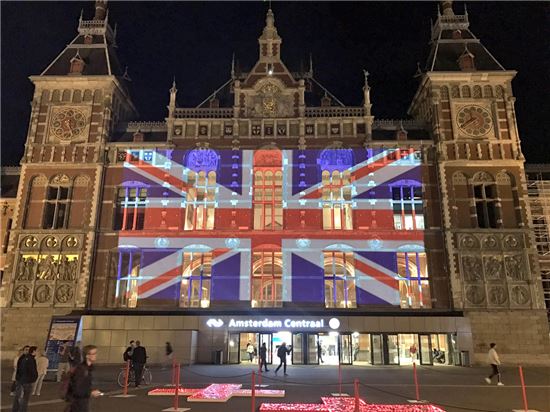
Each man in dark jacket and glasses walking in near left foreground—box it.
[65,345,103,412]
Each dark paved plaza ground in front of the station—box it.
[0,364,550,412]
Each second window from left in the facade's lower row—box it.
[180,252,212,308]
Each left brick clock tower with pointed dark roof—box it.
[0,1,137,350]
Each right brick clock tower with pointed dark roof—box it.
[409,1,548,361]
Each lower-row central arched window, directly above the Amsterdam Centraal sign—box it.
[251,251,283,308]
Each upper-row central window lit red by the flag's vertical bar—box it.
[252,150,283,230]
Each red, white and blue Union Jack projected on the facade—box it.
[114,148,430,308]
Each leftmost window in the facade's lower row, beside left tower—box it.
[115,250,141,308]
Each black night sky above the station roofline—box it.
[1,1,550,165]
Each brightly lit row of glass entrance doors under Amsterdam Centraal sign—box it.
[228,331,459,365]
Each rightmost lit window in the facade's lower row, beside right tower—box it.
[397,252,432,309]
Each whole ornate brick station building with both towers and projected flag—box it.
[1,1,550,364]
